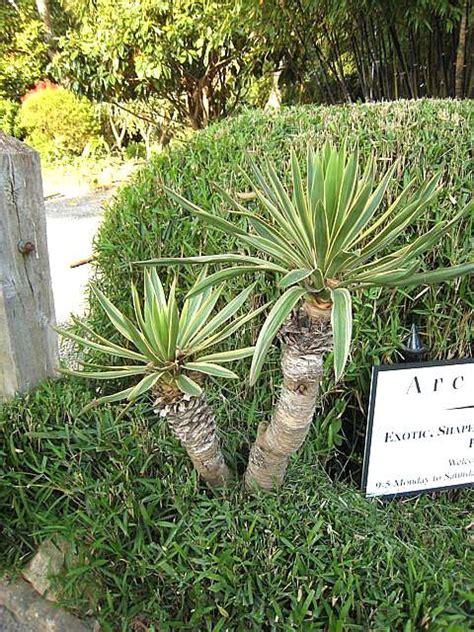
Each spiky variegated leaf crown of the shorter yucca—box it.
[56,269,266,403]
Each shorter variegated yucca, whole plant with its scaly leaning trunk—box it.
[58,270,263,486]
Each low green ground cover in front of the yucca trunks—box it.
[0,382,471,631]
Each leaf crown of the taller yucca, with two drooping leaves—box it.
[139,144,474,382]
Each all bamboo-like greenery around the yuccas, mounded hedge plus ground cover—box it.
[0,101,473,631]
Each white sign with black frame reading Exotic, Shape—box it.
[362,359,474,496]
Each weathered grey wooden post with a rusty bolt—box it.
[0,132,58,399]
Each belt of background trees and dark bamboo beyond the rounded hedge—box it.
[0,0,473,129]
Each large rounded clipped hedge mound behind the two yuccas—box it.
[91,100,473,460]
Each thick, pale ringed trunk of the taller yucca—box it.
[245,303,332,490]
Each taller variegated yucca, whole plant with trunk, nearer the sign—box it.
[139,144,474,489]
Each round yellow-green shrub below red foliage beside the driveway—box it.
[18,84,100,157]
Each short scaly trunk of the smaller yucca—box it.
[154,395,231,487]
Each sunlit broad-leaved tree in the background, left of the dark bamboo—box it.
[54,0,262,128]
